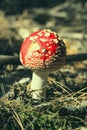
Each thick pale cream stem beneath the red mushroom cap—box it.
[30,70,49,100]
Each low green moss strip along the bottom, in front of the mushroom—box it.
[0,92,84,130]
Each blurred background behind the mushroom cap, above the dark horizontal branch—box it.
[0,0,87,55]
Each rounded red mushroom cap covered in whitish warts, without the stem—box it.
[20,29,66,70]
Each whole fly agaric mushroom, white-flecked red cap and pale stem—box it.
[20,29,66,100]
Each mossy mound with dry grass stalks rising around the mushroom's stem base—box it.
[0,71,87,130]
